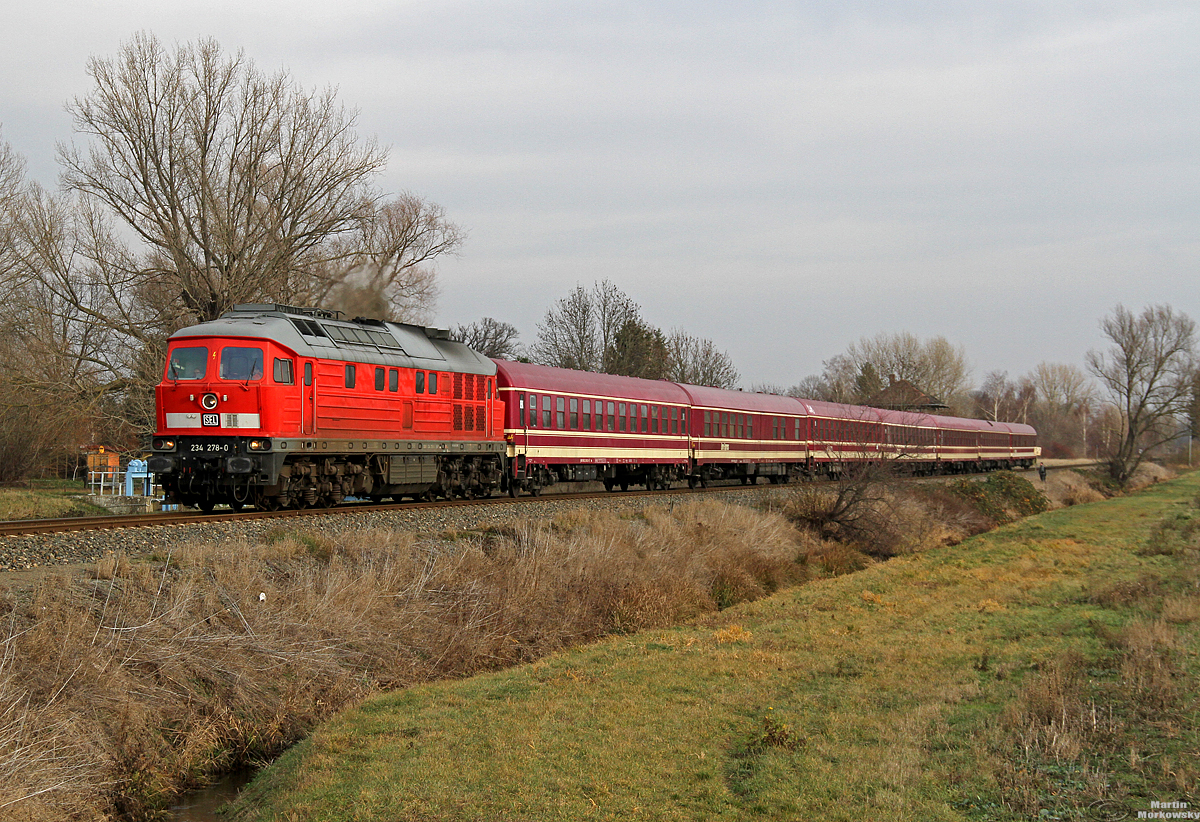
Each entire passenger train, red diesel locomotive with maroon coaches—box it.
[148,305,1040,510]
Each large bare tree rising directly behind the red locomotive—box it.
[59,34,461,330]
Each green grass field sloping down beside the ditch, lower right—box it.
[234,474,1200,822]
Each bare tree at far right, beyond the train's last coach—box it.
[1087,305,1195,485]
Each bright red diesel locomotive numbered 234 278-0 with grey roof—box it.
[148,305,504,510]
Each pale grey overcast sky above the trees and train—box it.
[0,0,1200,388]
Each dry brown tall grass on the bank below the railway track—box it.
[0,503,825,822]
